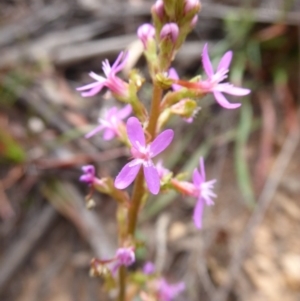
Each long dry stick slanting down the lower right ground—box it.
[213,129,300,301]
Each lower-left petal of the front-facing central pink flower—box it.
[115,159,141,189]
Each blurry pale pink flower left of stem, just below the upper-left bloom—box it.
[85,104,132,141]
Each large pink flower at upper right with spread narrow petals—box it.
[197,44,251,109]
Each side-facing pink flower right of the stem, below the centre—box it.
[193,157,217,229]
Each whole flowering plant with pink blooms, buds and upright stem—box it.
[77,0,250,301]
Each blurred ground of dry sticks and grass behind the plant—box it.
[0,0,300,301]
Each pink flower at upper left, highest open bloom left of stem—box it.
[76,52,128,97]
